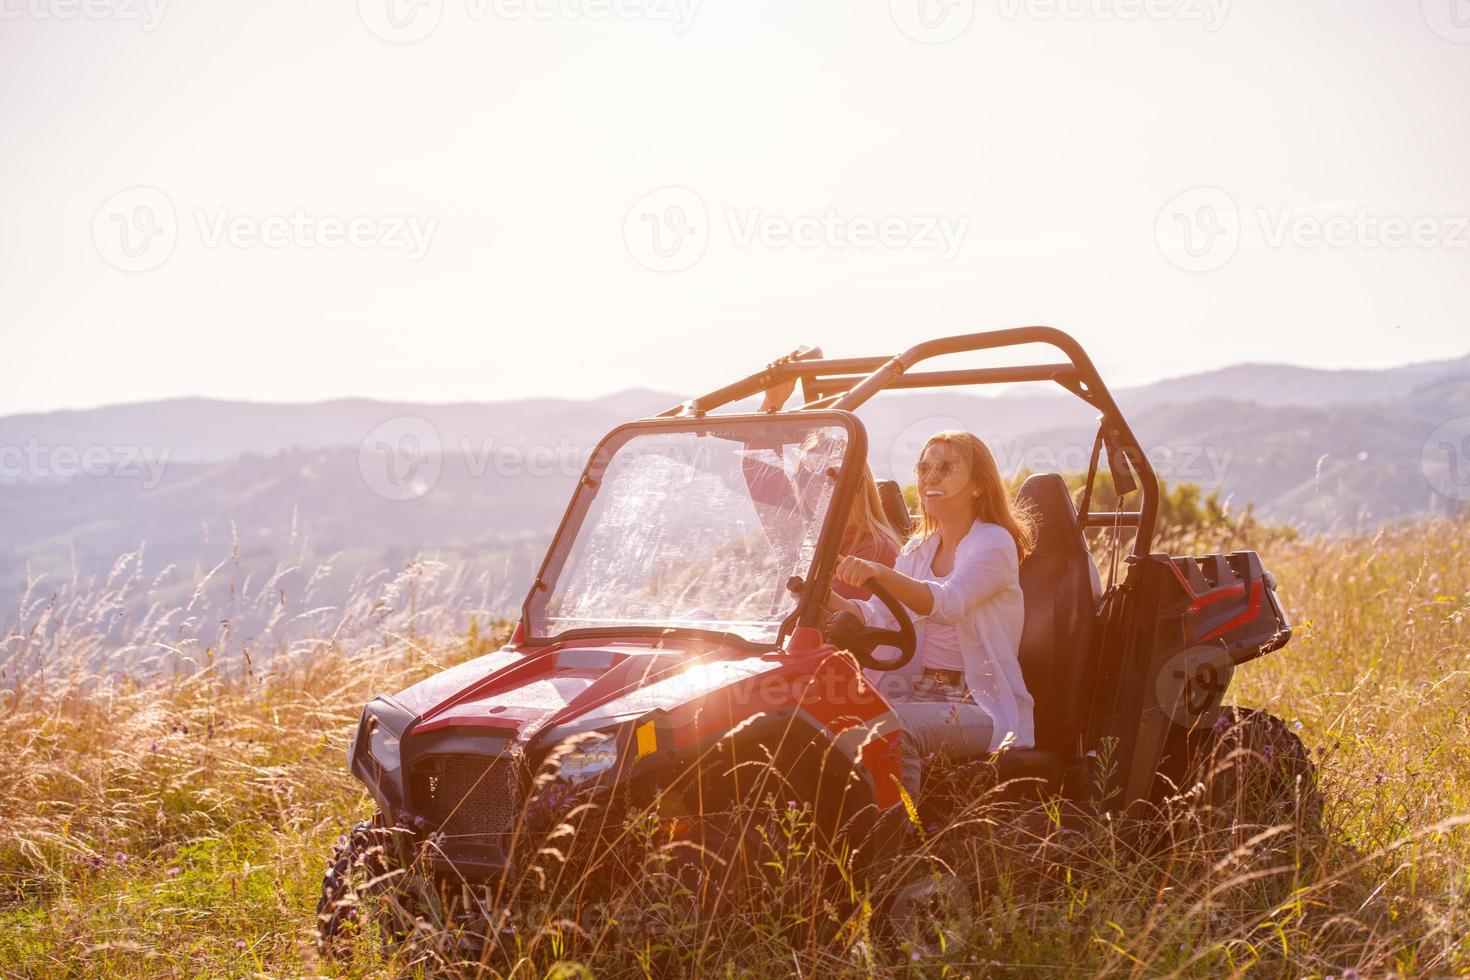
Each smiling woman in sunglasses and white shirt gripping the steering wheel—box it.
[826,430,1033,796]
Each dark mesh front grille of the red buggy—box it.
[415,754,522,843]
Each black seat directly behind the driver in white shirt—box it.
[1000,473,1097,780]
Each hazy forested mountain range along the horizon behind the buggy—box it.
[0,356,1470,628]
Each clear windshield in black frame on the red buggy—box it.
[528,417,848,644]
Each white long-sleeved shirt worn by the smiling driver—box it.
[857,520,1036,752]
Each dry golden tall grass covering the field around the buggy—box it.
[0,519,1470,977]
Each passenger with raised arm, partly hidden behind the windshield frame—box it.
[744,381,901,599]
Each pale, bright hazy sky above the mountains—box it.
[0,0,1470,413]
